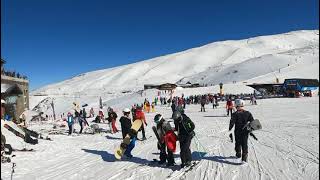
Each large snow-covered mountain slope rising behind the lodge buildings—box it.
[32,30,319,96]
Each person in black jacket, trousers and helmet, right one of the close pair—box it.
[172,109,195,168]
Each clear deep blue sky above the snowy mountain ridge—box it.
[1,0,319,90]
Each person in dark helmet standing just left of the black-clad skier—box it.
[154,114,175,166]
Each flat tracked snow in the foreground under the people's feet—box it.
[1,97,319,180]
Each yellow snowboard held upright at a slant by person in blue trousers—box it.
[114,119,142,160]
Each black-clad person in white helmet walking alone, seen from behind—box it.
[229,99,254,162]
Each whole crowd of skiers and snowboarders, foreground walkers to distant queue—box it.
[44,90,257,168]
